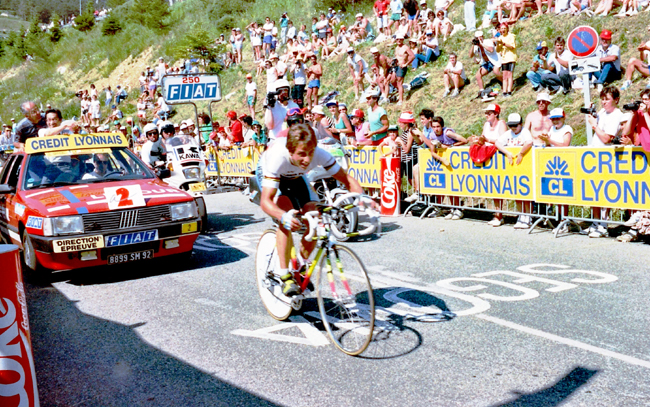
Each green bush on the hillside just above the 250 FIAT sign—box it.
[172,27,225,72]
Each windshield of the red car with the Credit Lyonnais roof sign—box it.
[23,148,154,189]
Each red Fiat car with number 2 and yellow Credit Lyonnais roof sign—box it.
[0,134,204,270]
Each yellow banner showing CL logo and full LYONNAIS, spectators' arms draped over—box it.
[418,147,534,201]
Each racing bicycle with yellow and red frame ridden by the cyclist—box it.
[255,193,380,356]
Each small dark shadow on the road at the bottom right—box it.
[493,367,598,407]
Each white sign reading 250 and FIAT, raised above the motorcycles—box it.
[162,73,221,104]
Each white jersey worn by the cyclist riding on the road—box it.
[262,138,341,189]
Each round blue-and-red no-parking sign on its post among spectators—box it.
[567,25,600,144]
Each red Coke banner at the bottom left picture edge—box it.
[0,245,40,407]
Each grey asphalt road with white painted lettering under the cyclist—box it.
[27,192,650,406]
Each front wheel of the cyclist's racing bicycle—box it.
[317,245,375,356]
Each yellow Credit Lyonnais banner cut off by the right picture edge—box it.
[535,147,650,210]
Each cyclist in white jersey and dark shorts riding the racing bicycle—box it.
[260,123,376,296]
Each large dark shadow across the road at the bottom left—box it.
[26,284,276,407]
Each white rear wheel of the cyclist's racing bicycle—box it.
[255,229,293,321]
